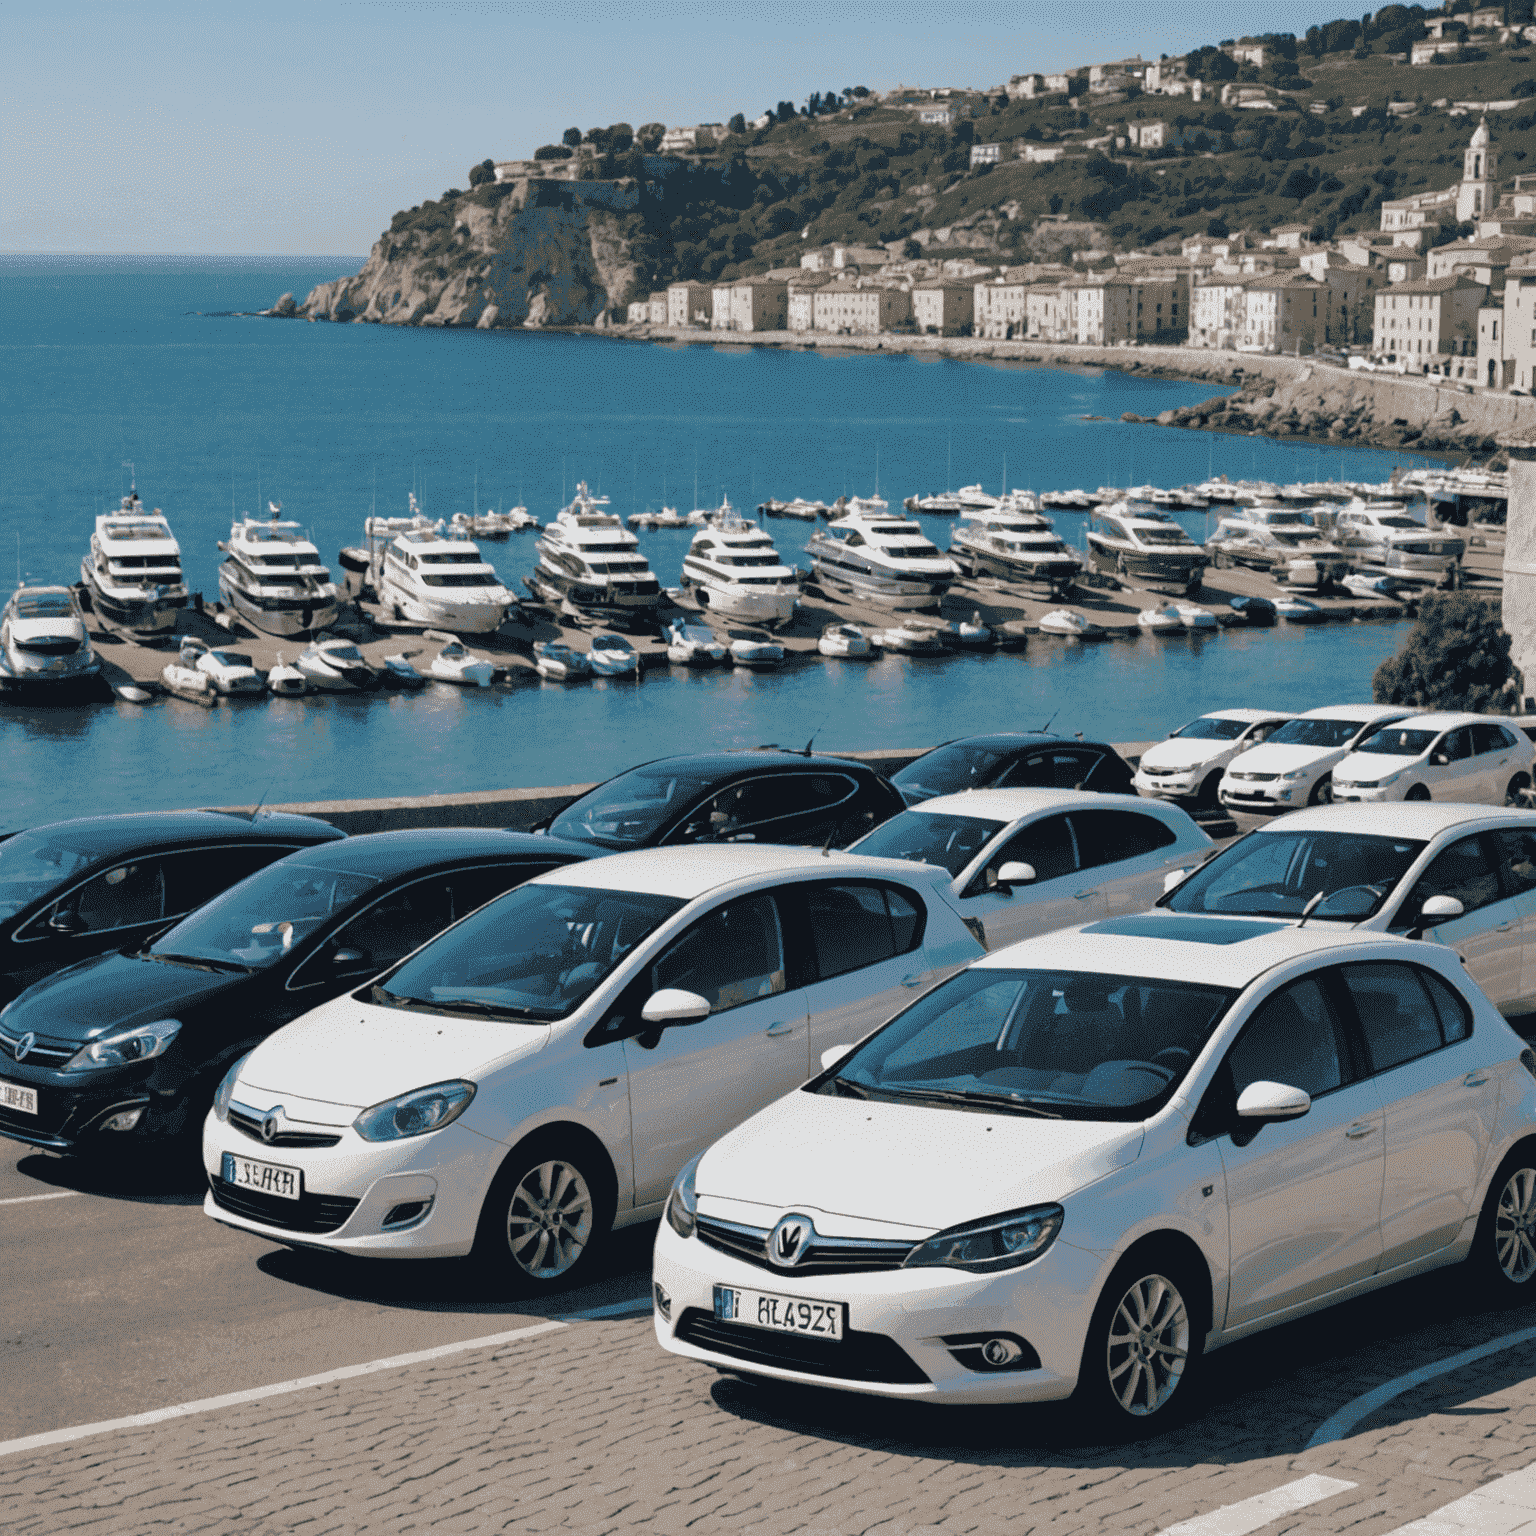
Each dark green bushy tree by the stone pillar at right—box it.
[1372,591,1519,713]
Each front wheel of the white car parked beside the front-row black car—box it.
[473,1132,614,1296]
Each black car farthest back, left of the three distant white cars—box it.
[891,731,1137,805]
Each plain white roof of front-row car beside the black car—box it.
[533,843,949,902]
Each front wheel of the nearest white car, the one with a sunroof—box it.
[1072,1244,1206,1439]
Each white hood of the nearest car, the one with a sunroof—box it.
[697,1091,1144,1232]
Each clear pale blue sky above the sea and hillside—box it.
[0,0,1358,255]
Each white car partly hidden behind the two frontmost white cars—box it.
[849,790,1217,949]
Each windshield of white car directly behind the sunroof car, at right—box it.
[1163,828,1424,922]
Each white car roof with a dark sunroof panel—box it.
[972,911,1424,991]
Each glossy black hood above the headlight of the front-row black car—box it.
[5,954,250,1040]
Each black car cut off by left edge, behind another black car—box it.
[0,811,346,1003]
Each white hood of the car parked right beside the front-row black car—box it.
[240,997,550,1109]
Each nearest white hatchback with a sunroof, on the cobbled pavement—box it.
[653,912,1536,1433]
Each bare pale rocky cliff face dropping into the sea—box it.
[269,178,639,330]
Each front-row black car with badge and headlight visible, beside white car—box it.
[0,828,594,1152]
